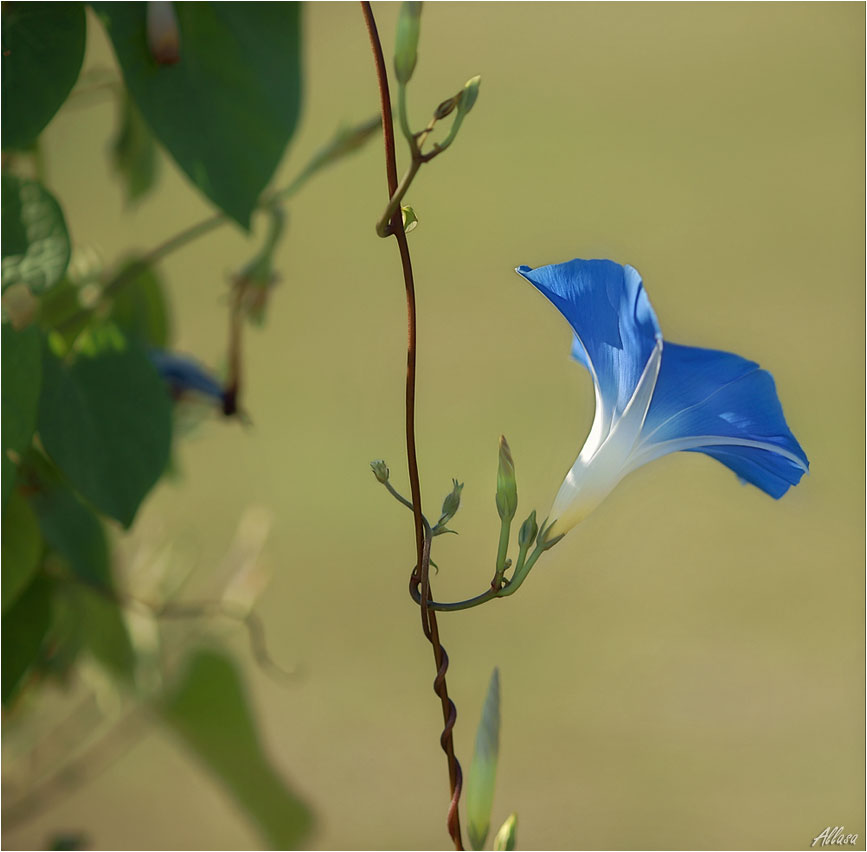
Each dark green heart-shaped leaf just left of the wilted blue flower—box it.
[39,346,171,527]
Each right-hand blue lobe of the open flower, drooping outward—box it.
[630,343,809,497]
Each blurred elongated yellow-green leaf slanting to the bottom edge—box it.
[162,651,312,849]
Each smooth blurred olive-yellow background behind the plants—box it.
[4,3,867,849]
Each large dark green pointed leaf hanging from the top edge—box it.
[95,2,301,229]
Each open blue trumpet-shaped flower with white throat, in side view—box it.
[516,260,809,535]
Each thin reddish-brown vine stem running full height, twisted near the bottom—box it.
[361,0,464,850]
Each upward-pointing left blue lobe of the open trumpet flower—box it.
[516,260,660,436]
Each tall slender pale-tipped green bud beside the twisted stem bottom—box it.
[466,669,500,849]
